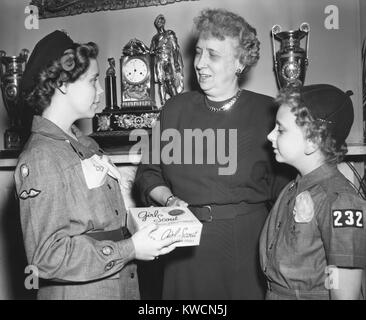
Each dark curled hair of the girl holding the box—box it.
[25,42,99,115]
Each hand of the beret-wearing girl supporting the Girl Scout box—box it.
[131,224,181,260]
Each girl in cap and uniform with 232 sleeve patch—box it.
[260,84,366,300]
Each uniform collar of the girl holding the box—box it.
[32,116,103,159]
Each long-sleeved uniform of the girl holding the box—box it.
[15,116,139,299]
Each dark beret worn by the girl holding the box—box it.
[21,30,74,94]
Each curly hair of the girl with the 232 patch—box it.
[276,86,347,163]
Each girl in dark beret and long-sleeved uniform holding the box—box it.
[15,31,179,299]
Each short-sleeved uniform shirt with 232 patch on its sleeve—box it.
[260,164,366,300]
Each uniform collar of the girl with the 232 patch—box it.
[295,163,338,193]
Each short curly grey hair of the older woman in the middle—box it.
[194,9,260,71]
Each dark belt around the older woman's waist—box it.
[188,202,267,222]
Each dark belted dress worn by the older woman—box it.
[135,90,289,300]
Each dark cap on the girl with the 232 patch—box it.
[300,84,354,145]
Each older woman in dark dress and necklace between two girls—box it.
[136,9,294,299]
